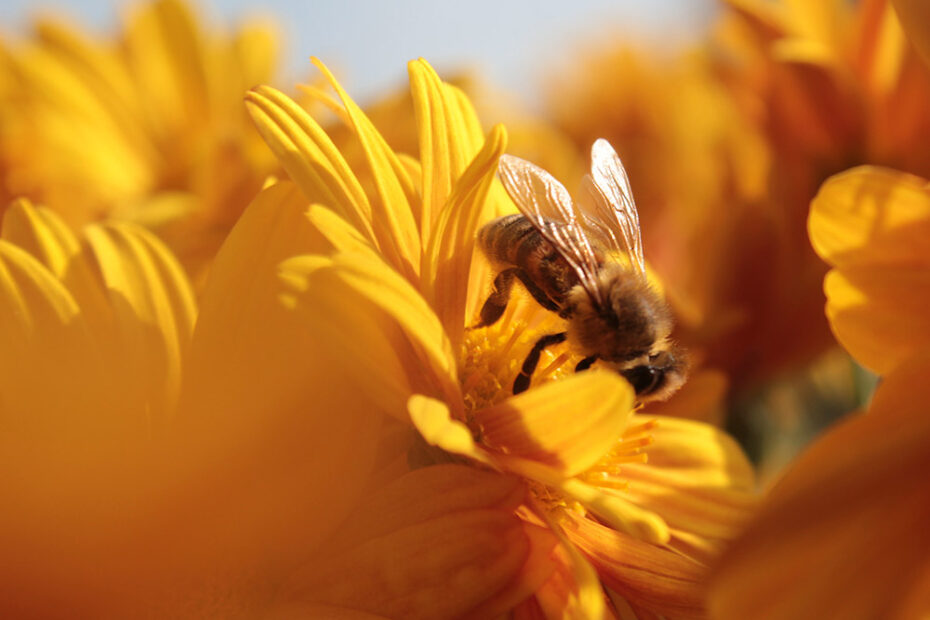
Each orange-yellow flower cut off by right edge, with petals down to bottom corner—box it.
[710,167,930,619]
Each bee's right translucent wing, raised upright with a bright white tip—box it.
[582,138,646,278]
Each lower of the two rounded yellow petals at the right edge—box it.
[824,266,930,375]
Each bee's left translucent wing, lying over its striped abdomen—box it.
[499,155,602,305]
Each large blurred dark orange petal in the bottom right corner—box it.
[709,356,930,620]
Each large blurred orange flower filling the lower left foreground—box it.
[0,193,554,618]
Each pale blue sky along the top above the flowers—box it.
[0,0,714,106]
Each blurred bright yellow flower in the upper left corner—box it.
[0,0,277,278]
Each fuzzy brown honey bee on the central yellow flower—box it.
[476,139,688,402]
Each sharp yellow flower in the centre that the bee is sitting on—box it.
[246,61,753,618]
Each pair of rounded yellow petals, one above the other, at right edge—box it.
[809,166,930,374]
